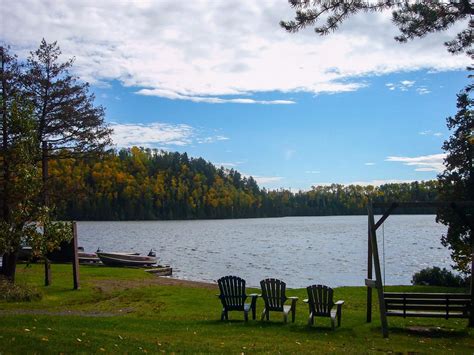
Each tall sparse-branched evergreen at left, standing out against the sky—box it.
[23,39,111,209]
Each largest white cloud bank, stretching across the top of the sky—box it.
[0,0,470,104]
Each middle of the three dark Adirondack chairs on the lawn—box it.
[260,279,298,323]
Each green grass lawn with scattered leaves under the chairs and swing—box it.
[0,265,474,354]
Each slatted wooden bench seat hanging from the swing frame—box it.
[383,292,471,319]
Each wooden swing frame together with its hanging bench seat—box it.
[365,201,474,337]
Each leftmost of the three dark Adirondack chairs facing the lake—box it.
[217,276,258,321]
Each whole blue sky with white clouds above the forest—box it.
[0,0,469,190]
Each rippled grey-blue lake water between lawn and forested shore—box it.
[78,215,450,287]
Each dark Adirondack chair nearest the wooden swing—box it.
[303,285,344,330]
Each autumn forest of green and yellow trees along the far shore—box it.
[48,147,437,220]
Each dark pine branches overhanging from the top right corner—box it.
[280,0,474,57]
